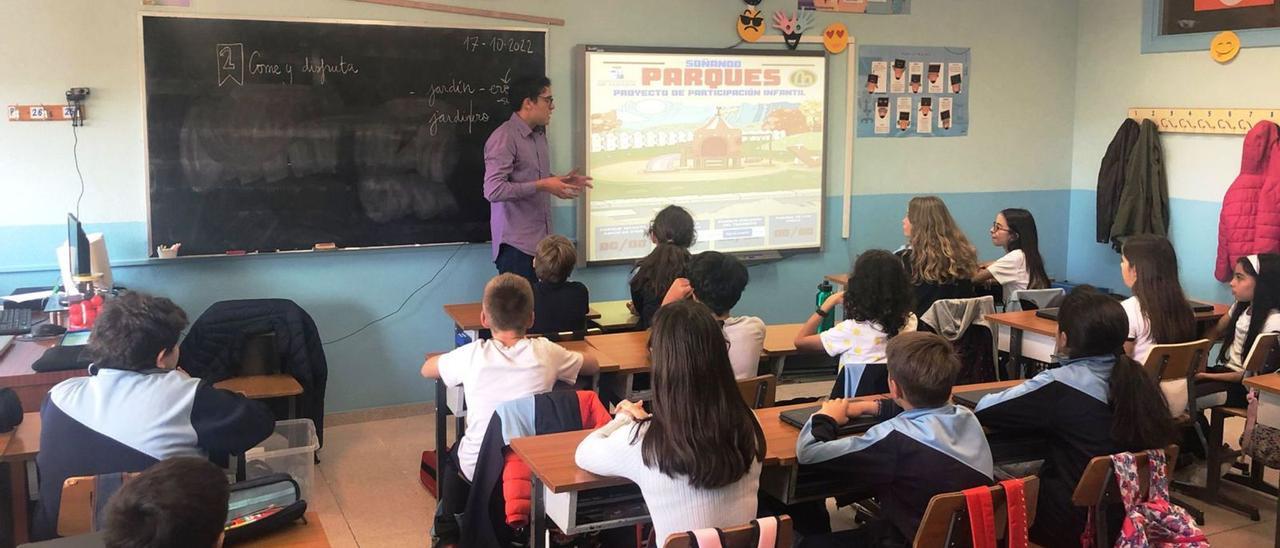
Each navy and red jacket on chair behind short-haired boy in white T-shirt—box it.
[461,391,612,547]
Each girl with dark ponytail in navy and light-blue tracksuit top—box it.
[975,286,1176,547]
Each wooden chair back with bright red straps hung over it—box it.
[913,476,1039,548]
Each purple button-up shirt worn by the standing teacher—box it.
[484,114,552,259]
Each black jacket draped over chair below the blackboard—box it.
[178,298,329,446]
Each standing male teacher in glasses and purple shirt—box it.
[484,76,591,284]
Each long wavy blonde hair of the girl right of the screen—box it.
[899,196,978,316]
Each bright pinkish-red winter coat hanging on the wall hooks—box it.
[1213,122,1280,282]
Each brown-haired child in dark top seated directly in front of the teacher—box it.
[529,234,591,333]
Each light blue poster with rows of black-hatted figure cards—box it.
[855,46,972,137]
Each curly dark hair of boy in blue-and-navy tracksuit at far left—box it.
[86,292,187,371]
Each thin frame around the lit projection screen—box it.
[575,44,831,266]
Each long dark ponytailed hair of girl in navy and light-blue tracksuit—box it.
[1057,286,1176,451]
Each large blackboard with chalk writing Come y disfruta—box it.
[142,15,547,255]
